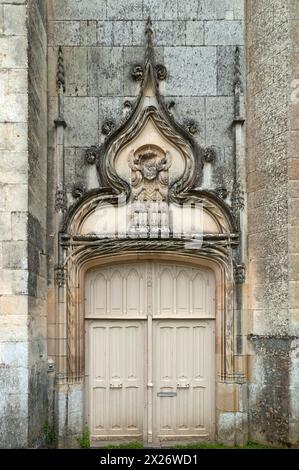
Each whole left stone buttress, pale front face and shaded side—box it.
[0,0,47,447]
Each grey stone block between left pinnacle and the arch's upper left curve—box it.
[64,97,98,147]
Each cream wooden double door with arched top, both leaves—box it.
[85,262,215,443]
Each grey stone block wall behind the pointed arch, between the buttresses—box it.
[48,0,244,204]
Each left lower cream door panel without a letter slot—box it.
[89,321,144,439]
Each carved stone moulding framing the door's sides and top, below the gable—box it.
[58,246,240,383]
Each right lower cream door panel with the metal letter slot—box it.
[153,320,214,440]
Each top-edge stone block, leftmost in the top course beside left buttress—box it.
[53,0,106,20]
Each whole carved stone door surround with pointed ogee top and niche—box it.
[56,17,244,444]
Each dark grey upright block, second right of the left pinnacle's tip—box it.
[88,47,123,96]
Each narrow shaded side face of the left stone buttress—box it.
[28,0,48,443]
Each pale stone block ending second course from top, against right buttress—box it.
[205,20,244,46]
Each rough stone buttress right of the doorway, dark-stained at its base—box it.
[246,0,299,443]
